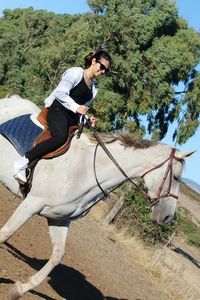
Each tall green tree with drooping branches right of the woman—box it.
[88,0,200,143]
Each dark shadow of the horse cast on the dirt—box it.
[0,242,127,300]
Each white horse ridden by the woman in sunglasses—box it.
[0,96,193,300]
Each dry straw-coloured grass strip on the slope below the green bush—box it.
[91,199,200,300]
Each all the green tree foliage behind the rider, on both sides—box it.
[0,0,200,144]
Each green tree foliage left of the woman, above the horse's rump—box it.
[0,7,79,104]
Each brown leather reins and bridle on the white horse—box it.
[87,122,183,206]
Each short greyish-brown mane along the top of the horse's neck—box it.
[89,131,158,149]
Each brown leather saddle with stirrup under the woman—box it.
[18,108,80,198]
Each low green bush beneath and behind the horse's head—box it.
[114,183,200,247]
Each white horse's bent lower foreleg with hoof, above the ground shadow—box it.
[9,220,70,300]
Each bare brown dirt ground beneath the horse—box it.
[0,185,200,300]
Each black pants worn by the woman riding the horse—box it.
[25,100,78,162]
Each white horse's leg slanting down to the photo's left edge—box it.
[0,196,43,243]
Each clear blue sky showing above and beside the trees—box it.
[0,0,200,184]
